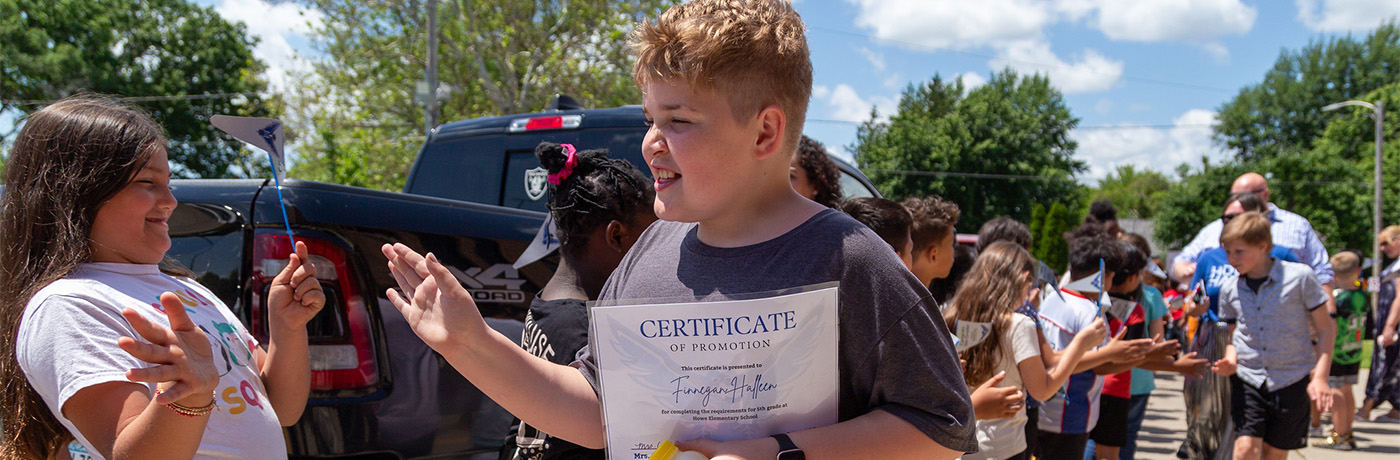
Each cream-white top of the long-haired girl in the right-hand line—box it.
[962,313,1040,460]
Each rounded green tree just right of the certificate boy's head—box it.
[853,70,1086,228]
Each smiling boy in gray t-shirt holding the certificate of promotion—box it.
[384,0,977,460]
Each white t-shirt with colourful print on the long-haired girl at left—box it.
[15,263,287,459]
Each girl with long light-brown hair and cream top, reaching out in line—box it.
[944,242,1107,459]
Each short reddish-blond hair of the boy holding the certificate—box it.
[633,0,812,152]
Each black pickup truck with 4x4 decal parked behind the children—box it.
[168,98,874,459]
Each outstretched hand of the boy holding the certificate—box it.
[382,243,487,352]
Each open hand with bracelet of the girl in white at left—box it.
[116,292,218,407]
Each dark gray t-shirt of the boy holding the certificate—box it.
[575,210,977,452]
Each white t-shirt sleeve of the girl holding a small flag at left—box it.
[15,295,151,410]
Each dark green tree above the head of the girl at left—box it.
[0,0,279,178]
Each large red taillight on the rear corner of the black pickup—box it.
[252,233,379,391]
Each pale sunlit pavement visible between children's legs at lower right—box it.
[1137,371,1400,460]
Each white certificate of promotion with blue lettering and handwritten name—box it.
[589,284,839,460]
